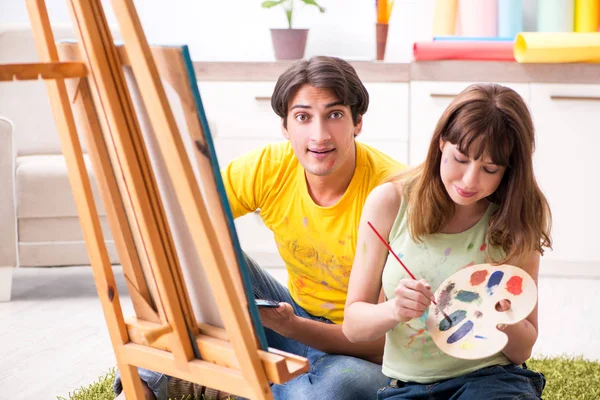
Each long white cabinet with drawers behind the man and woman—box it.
[199,81,600,272]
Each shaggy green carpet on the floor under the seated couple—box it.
[58,357,600,400]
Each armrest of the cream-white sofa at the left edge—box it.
[0,116,17,268]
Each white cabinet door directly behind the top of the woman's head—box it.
[408,81,529,165]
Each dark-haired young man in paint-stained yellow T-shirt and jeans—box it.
[115,57,402,400]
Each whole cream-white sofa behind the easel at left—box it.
[0,27,118,301]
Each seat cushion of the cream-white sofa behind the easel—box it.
[15,154,106,218]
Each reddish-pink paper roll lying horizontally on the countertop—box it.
[413,41,515,61]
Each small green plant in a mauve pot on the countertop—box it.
[262,0,325,60]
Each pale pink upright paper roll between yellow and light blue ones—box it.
[458,0,498,36]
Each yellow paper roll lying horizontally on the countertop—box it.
[514,32,600,63]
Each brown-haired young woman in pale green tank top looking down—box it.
[343,84,551,400]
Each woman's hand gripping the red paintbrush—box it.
[393,279,433,322]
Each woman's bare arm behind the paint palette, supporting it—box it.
[498,251,540,364]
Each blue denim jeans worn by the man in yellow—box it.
[114,257,389,400]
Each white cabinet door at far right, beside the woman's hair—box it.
[530,84,600,263]
